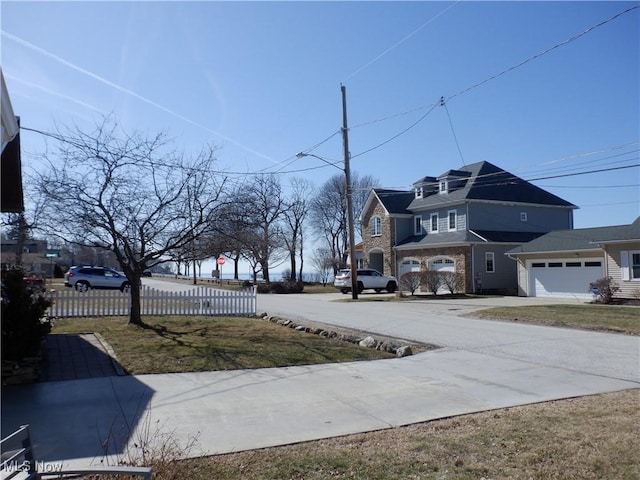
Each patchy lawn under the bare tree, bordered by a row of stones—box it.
[52,316,393,375]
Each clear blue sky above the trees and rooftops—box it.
[0,1,640,237]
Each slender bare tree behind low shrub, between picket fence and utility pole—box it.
[284,178,313,282]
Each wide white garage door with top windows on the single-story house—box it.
[528,258,604,300]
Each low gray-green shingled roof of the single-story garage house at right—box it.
[507,217,640,256]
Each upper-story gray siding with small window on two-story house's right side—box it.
[469,203,573,232]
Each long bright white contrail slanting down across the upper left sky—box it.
[2,30,277,163]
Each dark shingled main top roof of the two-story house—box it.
[409,161,578,210]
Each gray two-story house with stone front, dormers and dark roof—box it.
[360,162,577,294]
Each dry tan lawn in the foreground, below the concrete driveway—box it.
[183,390,640,480]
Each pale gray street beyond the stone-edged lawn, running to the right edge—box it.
[258,288,640,382]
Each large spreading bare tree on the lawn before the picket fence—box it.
[33,118,226,324]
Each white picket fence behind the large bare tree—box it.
[49,286,257,317]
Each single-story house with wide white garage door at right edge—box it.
[507,217,640,300]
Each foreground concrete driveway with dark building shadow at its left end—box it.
[2,348,638,466]
